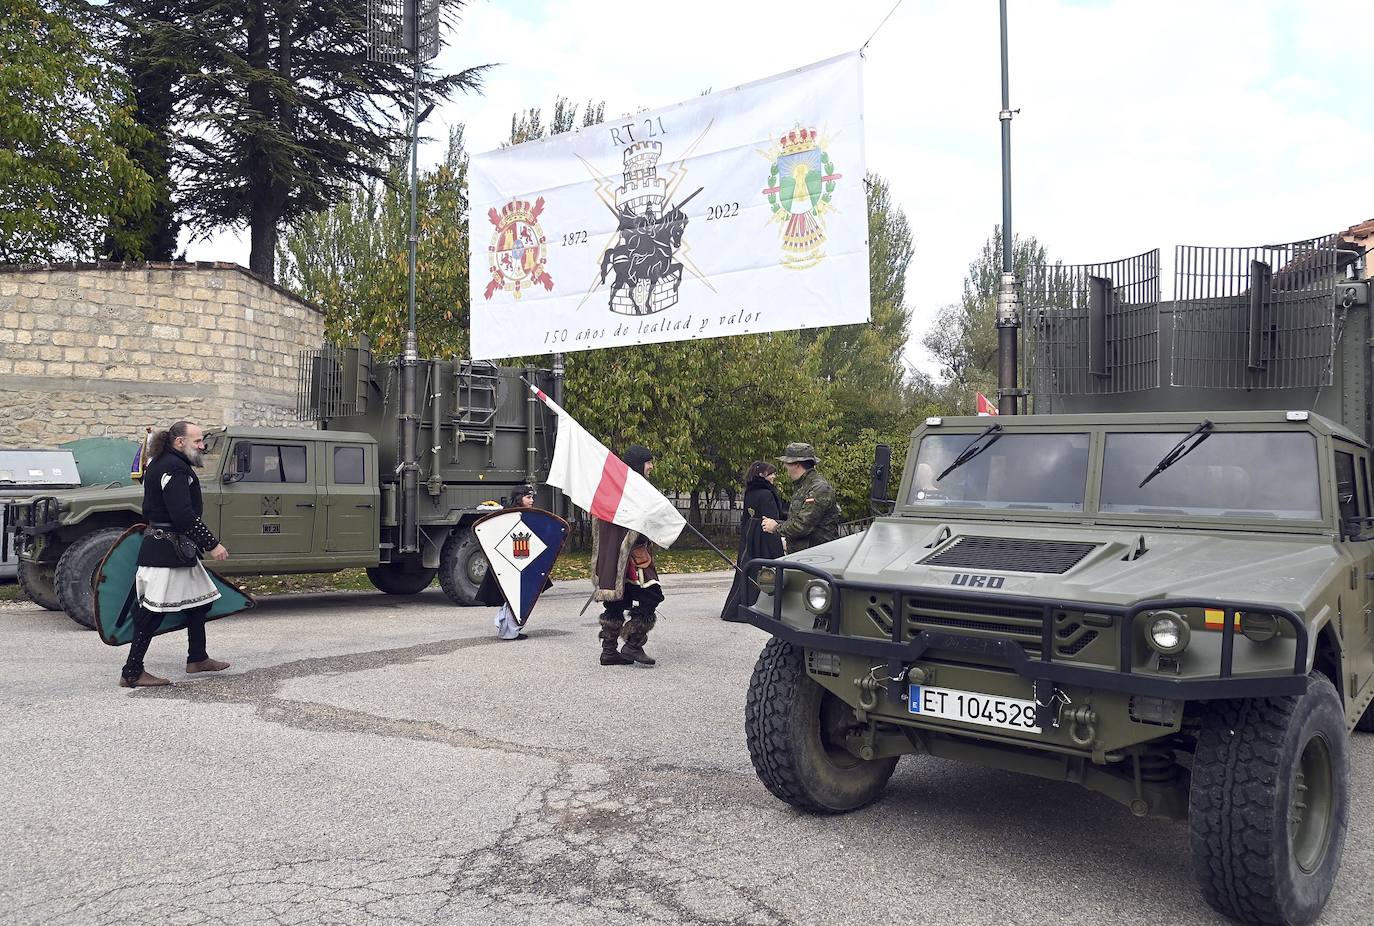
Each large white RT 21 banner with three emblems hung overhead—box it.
[469,52,868,360]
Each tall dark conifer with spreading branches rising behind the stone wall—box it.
[125,0,485,279]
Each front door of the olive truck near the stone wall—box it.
[221,440,319,556]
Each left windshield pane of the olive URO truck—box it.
[907,431,1088,511]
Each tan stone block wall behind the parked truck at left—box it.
[0,262,324,447]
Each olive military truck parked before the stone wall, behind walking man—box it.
[8,343,555,628]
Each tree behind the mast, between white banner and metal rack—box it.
[925,228,1046,414]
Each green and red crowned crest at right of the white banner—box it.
[763,124,844,271]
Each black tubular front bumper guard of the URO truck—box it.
[739,559,1308,705]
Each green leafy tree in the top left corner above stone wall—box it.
[0,0,154,262]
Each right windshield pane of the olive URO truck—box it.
[1101,430,1322,519]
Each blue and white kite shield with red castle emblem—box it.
[473,508,567,625]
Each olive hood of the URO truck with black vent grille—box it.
[818,519,1352,613]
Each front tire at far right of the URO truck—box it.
[1189,673,1349,926]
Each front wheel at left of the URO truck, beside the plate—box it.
[745,639,897,813]
